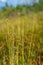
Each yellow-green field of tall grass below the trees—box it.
[0,13,43,65]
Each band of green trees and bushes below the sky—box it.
[0,0,43,18]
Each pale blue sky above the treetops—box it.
[0,0,38,7]
